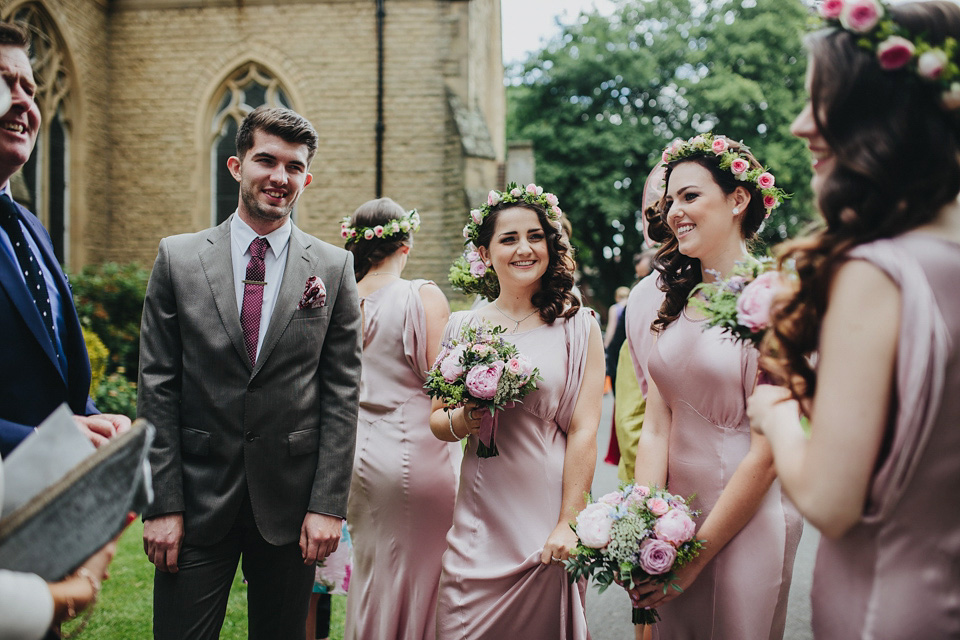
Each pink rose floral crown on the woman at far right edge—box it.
[819,0,960,110]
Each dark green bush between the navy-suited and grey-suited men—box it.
[70,262,150,381]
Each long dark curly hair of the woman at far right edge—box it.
[761,2,960,406]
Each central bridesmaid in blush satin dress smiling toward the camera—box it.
[430,186,604,640]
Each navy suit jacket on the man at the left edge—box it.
[0,200,97,456]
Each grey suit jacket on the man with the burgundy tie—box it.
[137,219,361,545]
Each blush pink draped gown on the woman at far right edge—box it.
[812,233,960,640]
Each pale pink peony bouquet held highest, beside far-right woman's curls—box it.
[691,257,782,347]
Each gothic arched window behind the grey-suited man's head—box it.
[210,62,291,225]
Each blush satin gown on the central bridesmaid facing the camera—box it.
[437,309,596,640]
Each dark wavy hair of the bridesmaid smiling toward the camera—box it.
[476,202,580,324]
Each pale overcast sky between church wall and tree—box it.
[500,0,613,65]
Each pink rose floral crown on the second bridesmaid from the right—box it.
[661,133,790,217]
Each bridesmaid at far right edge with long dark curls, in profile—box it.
[748,2,960,640]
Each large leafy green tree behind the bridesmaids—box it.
[507,0,811,304]
